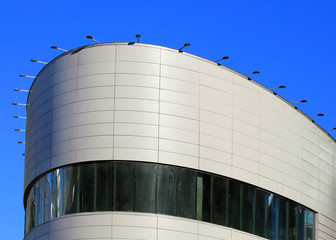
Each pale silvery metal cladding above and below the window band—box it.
[24,43,336,240]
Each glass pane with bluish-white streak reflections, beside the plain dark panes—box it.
[62,166,79,215]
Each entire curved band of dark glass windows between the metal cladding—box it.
[25,161,315,240]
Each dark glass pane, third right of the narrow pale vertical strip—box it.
[228,181,242,229]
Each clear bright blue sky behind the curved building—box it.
[0,0,336,240]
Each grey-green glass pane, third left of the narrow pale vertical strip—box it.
[135,163,156,213]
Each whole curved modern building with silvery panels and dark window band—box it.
[24,43,336,240]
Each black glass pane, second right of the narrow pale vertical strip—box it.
[211,176,228,226]
